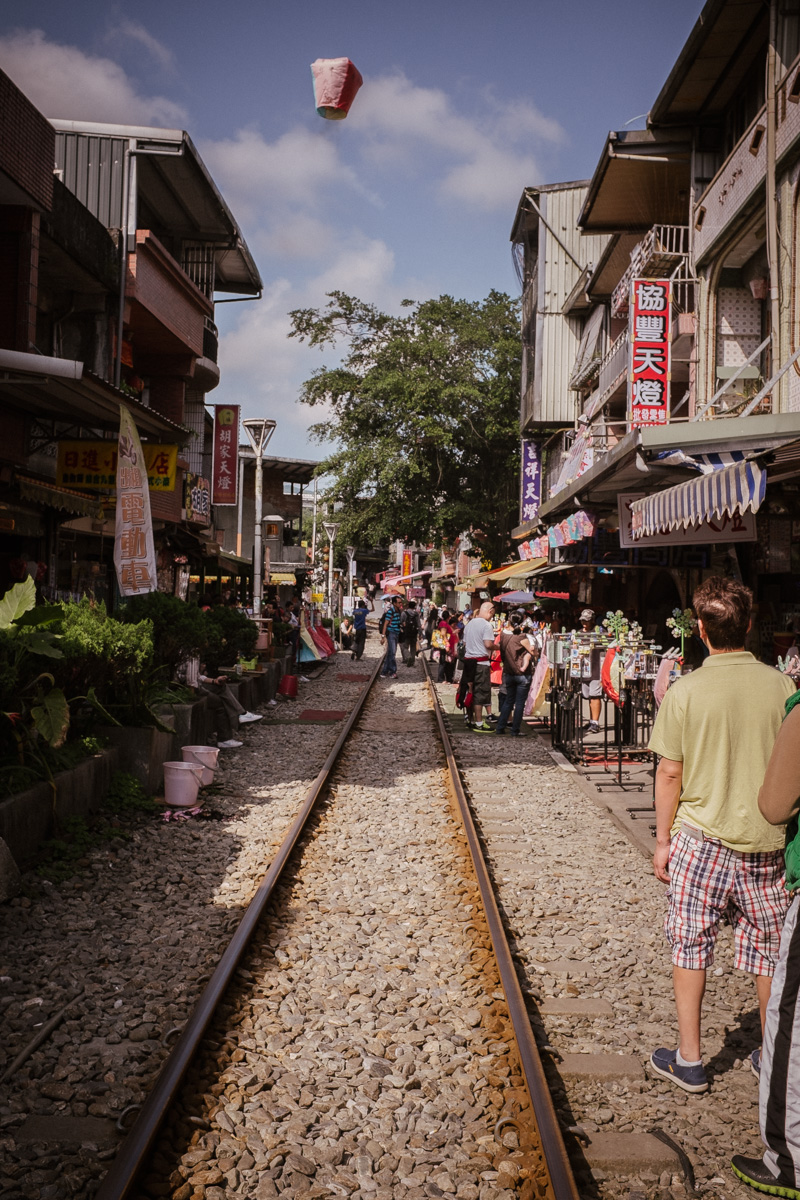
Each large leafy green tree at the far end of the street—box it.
[289,292,521,564]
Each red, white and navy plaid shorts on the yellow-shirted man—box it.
[664,828,789,976]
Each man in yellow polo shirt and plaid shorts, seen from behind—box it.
[650,576,794,1092]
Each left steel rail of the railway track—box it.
[95,656,384,1200]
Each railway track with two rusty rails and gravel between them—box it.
[87,664,578,1200]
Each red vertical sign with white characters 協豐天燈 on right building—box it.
[628,280,672,428]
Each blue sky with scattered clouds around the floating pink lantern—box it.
[0,0,700,458]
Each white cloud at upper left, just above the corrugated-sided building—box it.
[0,29,186,127]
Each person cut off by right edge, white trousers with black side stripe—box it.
[730,692,800,1198]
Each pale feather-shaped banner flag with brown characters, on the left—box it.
[114,406,157,596]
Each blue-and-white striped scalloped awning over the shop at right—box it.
[631,462,766,539]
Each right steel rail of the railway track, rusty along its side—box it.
[422,656,581,1200]
